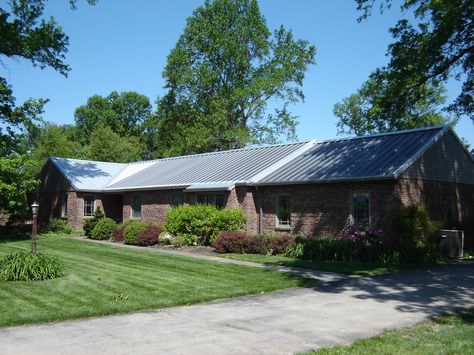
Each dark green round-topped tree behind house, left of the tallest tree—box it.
[74,91,152,144]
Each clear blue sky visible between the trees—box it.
[0,0,474,146]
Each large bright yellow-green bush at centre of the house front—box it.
[164,205,246,245]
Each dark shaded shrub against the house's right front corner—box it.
[392,205,441,247]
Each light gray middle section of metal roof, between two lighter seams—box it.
[105,142,309,191]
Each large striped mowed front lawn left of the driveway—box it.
[0,238,309,326]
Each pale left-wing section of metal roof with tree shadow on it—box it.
[50,157,127,191]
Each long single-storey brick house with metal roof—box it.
[38,126,474,243]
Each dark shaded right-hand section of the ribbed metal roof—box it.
[259,127,448,184]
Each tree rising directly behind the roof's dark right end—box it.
[333,70,457,135]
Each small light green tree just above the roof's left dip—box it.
[87,126,143,163]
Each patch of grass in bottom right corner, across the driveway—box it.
[309,308,474,355]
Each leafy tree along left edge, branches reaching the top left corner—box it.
[0,0,96,222]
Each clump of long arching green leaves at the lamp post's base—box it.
[0,250,64,281]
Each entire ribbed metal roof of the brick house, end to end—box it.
[47,127,454,192]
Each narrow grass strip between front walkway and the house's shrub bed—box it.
[219,254,412,276]
